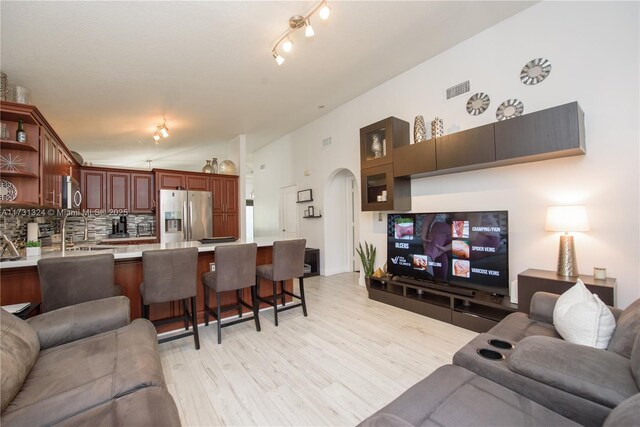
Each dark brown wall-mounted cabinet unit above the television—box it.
[360,102,586,211]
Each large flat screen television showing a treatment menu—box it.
[387,211,509,295]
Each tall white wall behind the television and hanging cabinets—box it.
[255,2,640,307]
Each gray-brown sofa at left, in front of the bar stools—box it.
[0,296,180,427]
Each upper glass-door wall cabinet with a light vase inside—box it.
[360,117,409,169]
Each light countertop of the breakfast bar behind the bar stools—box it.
[0,237,291,270]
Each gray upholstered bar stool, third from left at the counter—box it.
[202,243,260,344]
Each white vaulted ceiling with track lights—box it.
[0,0,532,170]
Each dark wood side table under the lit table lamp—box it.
[518,268,616,314]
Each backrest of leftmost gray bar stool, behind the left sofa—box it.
[38,253,121,312]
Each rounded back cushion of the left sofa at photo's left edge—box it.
[0,310,40,411]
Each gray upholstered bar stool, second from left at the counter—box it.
[140,248,200,350]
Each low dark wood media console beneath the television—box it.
[367,277,518,332]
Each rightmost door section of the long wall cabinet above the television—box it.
[495,102,585,161]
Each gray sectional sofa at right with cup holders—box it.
[361,292,640,426]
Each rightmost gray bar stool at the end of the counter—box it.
[256,239,307,326]
